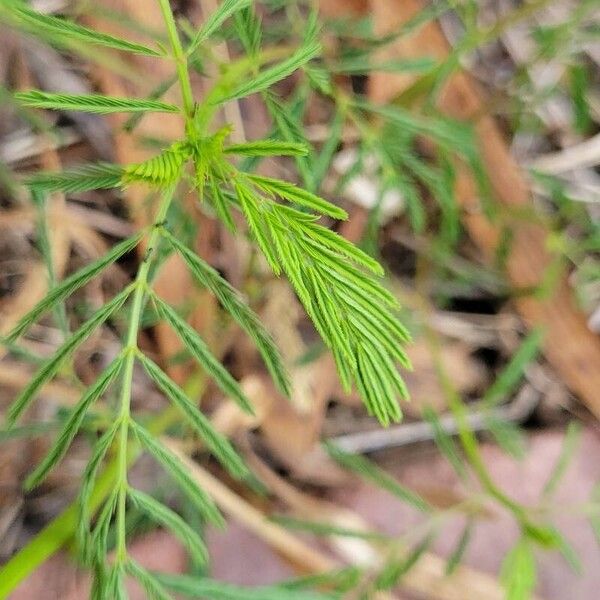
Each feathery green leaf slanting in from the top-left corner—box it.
[1,0,161,56]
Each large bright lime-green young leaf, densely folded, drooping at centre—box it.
[244,195,410,425]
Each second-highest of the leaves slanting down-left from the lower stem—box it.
[6,286,132,428]
